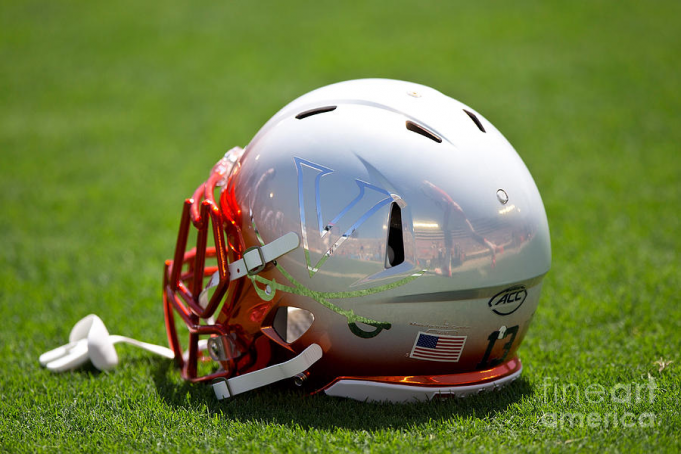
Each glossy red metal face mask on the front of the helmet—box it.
[163,148,245,382]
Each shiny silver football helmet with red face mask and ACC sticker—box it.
[163,79,551,402]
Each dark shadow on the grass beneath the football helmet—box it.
[154,362,533,430]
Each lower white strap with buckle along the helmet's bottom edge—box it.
[213,344,323,400]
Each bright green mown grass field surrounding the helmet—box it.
[0,0,681,453]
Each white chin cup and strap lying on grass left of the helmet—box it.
[39,314,175,372]
